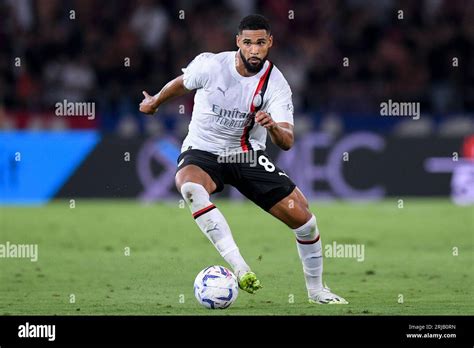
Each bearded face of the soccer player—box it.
[236,29,273,73]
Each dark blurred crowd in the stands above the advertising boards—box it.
[0,0,474,136]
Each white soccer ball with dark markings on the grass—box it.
[194,266,239,309]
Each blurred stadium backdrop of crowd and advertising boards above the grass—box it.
[0,0,474,203]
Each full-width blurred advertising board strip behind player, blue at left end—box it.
[0,131,474,204]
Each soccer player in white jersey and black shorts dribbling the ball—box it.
[140,15,347,304]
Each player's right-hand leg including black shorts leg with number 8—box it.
[233,150,347,303]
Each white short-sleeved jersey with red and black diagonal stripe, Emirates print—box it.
[181,51,293,155]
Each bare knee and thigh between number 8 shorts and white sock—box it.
[268,187,312,229]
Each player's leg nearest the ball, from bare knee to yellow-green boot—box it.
[175,164,259,293]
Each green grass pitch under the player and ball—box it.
[0,198,474,315]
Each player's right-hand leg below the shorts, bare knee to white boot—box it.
[268,187,348,304]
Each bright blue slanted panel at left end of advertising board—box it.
[0,131,100,204]
